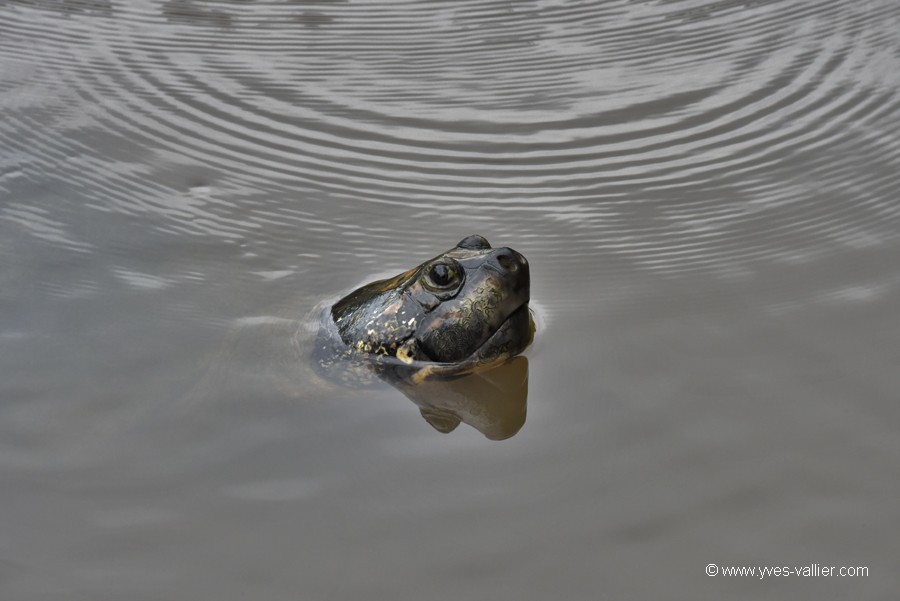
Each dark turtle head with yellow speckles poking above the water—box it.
[331,236,532,364]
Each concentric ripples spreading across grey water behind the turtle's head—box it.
[0,0,900,296]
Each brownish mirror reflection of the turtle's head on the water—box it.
[394,356,528,440]
